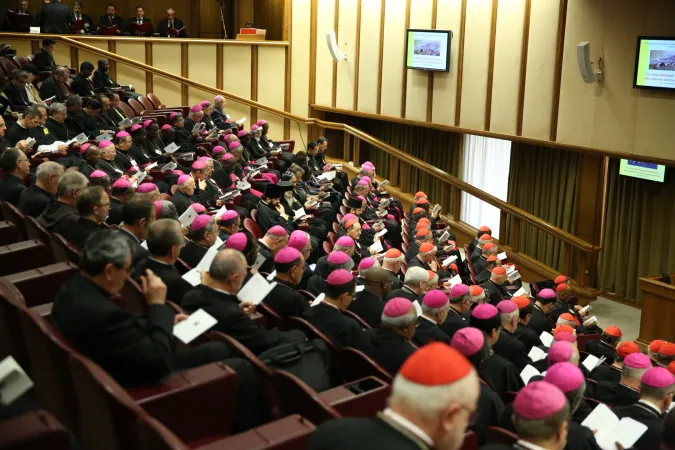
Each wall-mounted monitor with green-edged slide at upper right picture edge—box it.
[633,36,675,89]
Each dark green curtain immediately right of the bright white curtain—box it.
[500,142,579,271]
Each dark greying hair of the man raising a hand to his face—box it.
[80,230,131,276]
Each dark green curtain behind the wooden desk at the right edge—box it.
[599,158,675,305]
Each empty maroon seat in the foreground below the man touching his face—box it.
[69,354,246,449]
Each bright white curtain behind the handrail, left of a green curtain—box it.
[460,134,511,238]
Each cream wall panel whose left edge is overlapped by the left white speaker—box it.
[335,0,360,109]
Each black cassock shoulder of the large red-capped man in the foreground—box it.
[307,413,431,450]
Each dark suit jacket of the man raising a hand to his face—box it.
[52,275,175,387]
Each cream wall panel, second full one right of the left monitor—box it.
[488,0,526,135]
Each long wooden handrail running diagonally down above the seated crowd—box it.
[9,35,601,287]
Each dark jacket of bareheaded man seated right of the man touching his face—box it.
[183,285,297,355]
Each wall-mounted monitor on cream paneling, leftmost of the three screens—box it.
[406,30,452,72]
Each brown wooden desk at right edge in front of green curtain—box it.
[638,273,675,344]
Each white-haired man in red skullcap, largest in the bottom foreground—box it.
[308,342,480,450]
